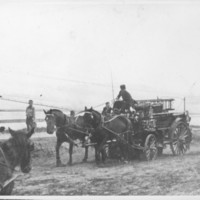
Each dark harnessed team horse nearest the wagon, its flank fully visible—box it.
[83,108,132,163]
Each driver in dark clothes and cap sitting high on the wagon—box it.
[117,85,137,113]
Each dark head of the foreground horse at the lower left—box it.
[6,128,34,173]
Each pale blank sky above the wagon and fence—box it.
[0,0,200,113]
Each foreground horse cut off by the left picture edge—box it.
[0,128,34,195]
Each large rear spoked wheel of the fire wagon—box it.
[170,122,192,155]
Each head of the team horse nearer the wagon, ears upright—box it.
[83,107,101,128]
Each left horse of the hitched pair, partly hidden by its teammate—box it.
[44,109,89,167]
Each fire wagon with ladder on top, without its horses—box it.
[101,99,192,161]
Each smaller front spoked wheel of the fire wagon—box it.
[144,134,158,161]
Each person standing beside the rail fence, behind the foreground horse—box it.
[26,100,36,131]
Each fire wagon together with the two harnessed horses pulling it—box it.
[45,99,192,166]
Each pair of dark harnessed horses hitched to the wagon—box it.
[44,98,132,166]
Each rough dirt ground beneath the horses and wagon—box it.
[13,130,200,195]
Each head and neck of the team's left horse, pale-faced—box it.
[44,109,66,134]
